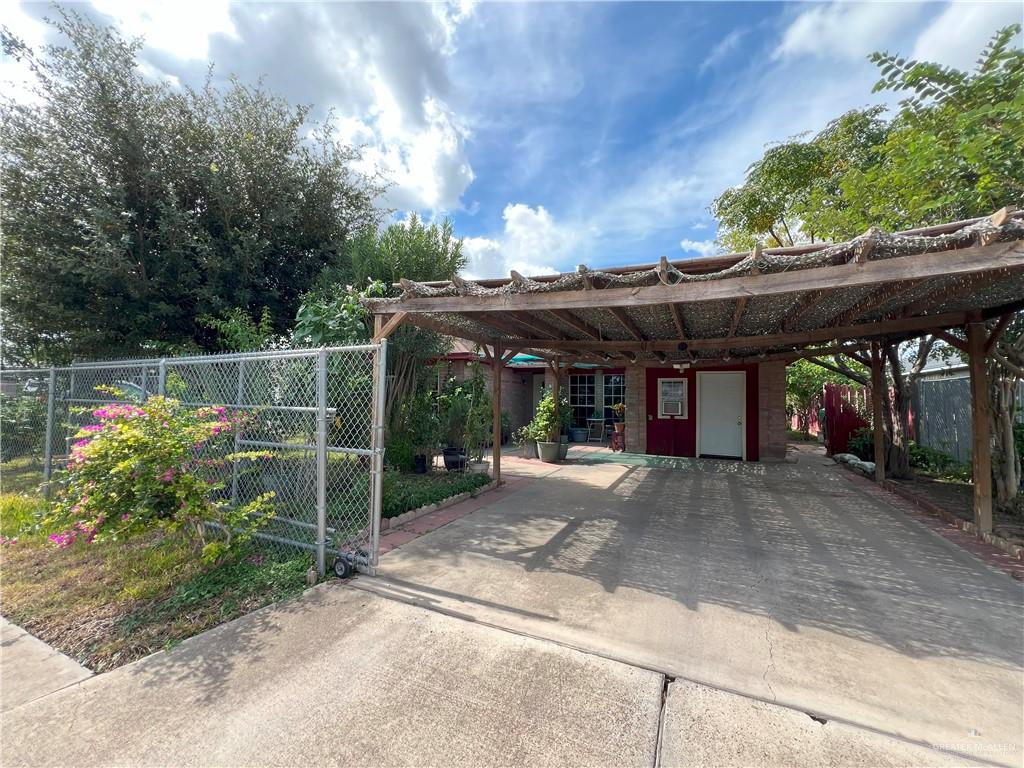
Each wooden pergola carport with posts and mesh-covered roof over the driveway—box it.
[367,208,1024,531]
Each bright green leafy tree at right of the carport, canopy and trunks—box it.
[712,25,1024,499]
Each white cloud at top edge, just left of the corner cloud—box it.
[774,2,924,59]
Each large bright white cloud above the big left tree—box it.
[9,0,474,214]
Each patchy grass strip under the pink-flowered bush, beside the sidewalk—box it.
[0,495,312,672]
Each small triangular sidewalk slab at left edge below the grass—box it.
[0,616,92,712]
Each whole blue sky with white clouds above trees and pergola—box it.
[0,0,1024,276]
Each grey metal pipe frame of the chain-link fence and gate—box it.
[2,339,387,575]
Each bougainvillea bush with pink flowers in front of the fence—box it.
[47,390,273,560]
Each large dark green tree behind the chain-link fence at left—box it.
[0,9,380,362]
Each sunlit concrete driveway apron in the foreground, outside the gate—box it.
[0,583,970,768]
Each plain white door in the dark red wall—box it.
[697,371,746,459]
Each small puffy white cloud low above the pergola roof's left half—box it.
[462,203,577,280]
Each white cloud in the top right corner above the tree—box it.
[912,2,1024,71]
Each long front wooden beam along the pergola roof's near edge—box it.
[382,241,1024,312]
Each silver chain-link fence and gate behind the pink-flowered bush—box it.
[0,341,387,573]
